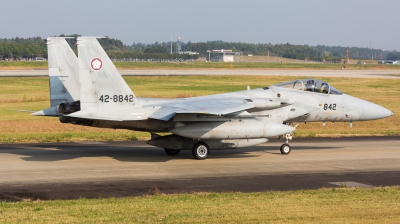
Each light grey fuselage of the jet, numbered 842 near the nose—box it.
[81,79,393,132]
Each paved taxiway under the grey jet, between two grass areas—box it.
[0,137,400,200]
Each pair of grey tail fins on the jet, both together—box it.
[31,37,143,120]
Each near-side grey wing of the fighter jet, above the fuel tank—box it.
[149,99,255,121]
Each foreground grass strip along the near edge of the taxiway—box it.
[0,187,400,223]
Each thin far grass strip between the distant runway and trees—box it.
[0,58,400,70]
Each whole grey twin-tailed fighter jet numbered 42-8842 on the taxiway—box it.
[32,37,393,159]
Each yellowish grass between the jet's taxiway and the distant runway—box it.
[0,76,400,143]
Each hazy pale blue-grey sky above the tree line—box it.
[0,0,400,51]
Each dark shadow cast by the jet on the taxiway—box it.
[0,143,341,162]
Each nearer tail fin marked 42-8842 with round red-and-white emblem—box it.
[78,37,137,112]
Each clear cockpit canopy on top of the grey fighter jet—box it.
[268,79,342,95]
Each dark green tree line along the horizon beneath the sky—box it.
[0,34,394,61]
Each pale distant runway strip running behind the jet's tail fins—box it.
[0,69,400,79]
